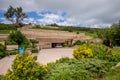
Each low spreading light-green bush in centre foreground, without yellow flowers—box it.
[45,58,113,80]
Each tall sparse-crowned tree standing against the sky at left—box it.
[4,6,27,29]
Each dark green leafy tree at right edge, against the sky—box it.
[104,23,120,46]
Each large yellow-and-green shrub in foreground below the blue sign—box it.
[6,53,47,80]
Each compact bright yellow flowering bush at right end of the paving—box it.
[73,45,93,59]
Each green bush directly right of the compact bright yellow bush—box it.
[86,44,120,62]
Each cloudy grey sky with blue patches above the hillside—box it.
[0,0,120,27]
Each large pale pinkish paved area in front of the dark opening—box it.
[37,48,74,64]
